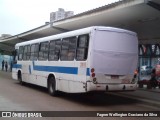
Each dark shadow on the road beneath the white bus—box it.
[16,83,138,106]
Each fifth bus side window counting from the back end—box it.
[30,43,39,60]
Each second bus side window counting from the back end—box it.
[61,37,77,61]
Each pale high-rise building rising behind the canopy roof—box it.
[50,8,74,22]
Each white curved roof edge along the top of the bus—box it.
[15,26,137,47]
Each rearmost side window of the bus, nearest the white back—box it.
[76,35,89,61]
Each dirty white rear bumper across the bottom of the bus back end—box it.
[86,82,137,92]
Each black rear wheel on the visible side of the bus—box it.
[48,76,57,96]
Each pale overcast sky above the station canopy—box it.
[0,0,119,36]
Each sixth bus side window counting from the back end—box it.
[23,45,31,60]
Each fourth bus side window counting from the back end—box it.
[38,42,49,60]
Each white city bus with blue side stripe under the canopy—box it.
[12,26,138,96]
